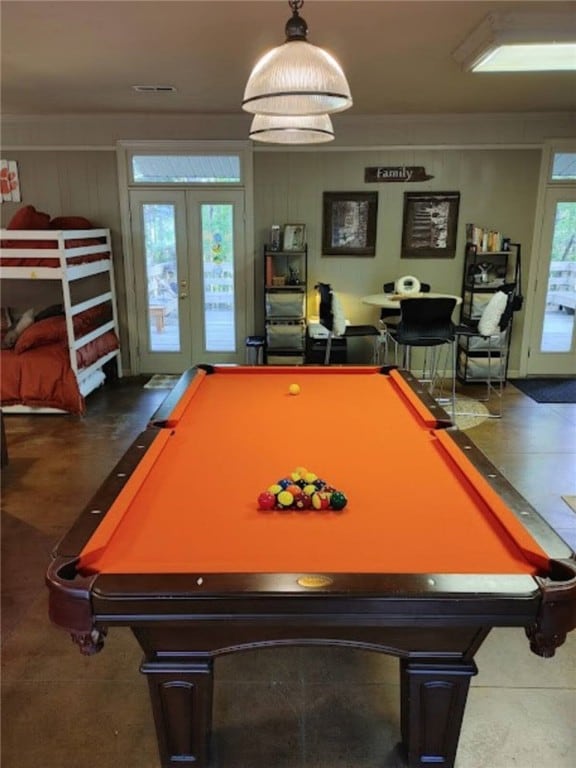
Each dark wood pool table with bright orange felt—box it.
[47,365,576,768]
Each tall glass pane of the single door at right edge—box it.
[540,203,576,352]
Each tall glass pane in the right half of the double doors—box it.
[200,203,236,352]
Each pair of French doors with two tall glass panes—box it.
[129,190,246,374]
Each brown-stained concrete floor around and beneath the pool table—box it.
[1,379,576,768]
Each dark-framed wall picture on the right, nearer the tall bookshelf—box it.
[401,192,460,259]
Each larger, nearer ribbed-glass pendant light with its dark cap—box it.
[242,0,352,116]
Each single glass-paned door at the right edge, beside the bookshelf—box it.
[526,187,576,376]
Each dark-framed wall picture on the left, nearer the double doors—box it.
[322,192,378,256]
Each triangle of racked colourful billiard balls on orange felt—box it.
[258,467,348,512]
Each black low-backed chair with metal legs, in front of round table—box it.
[395,298,457,418]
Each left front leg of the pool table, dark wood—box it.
[140,657,213,768]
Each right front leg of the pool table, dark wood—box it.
[400,659,478,768]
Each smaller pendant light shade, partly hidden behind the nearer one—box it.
[250,115,334,144]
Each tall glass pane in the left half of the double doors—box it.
[142,203,180,352]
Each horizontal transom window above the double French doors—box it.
[132,155,240,184]
